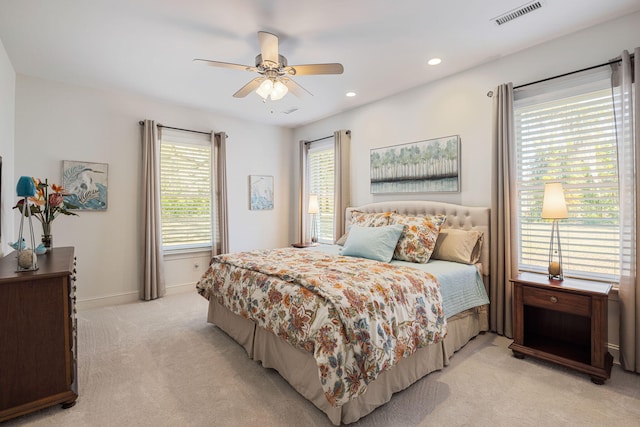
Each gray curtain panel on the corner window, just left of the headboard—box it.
[333,129,351,239]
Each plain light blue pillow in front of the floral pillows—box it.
[342,224,404,262]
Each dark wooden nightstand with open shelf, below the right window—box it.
[509,273,613,384]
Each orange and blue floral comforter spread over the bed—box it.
[197,248,447,406]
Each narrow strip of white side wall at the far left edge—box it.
[0,40,16,256]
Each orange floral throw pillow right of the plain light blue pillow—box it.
[391,214,447,264]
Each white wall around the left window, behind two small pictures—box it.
[14,75,295,308]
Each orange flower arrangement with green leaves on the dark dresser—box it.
[13,178,78,242]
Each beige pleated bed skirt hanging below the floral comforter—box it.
[207,301,489,425]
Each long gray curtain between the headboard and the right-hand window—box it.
[489,83,518,337]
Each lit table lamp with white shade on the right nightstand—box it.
[542,182,569,280]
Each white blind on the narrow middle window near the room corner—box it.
[308,138,335,243]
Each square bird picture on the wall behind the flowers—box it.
[62,160,109,211]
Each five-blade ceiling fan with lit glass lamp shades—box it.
[194,31,344,101]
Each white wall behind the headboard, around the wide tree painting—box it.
[294,13,640,356]
